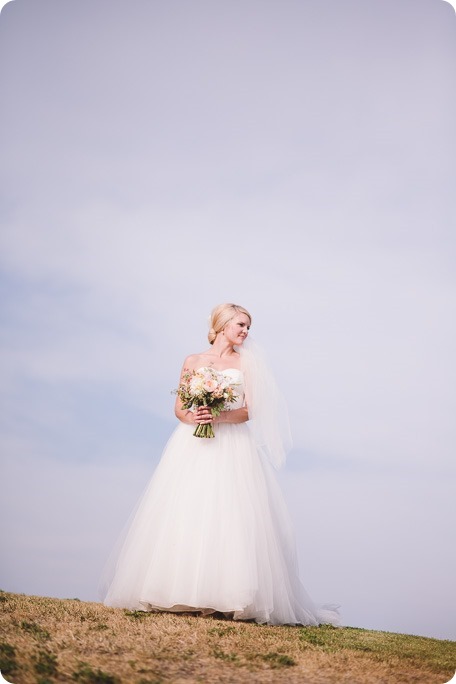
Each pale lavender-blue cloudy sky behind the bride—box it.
[0,0,456,639]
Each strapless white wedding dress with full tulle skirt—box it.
[104,369,339,625]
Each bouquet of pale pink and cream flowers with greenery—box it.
[174,368,238,437]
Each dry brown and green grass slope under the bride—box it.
[0,592,456,684]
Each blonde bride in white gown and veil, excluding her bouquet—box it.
[104,304,339,625]
